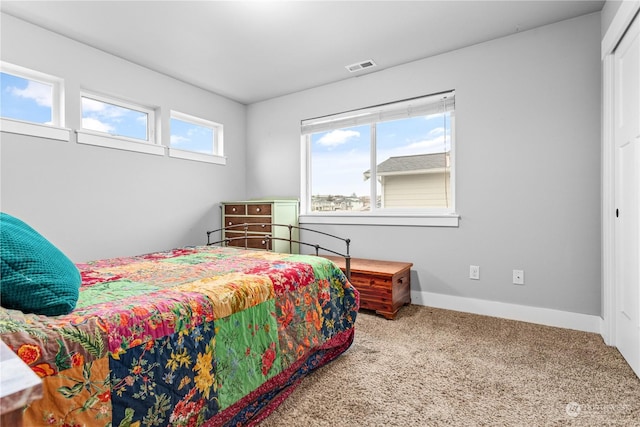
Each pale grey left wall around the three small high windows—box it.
[0,14,246,262]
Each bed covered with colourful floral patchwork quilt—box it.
[0,214,359,427]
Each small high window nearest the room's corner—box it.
[169,111,223,163]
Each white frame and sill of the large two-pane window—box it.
[300,91,460,227]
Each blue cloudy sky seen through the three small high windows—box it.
[0,72,214,154]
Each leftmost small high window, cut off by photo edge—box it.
[0,62,64,127]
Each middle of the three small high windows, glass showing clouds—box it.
[81,94,154,143]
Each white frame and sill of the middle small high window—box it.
[76,90,166,156]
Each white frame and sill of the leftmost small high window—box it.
[0,61,71,142]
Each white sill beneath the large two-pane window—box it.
[300,214,460,227]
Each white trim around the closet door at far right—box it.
[600,0,640,346]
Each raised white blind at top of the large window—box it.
[301,91,455,135]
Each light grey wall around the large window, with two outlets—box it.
[246,13,601,316]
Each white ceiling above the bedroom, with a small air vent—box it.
[0,0,604,104]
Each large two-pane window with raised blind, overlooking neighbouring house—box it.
[302,92,455,222]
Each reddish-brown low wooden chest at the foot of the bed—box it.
[323,255,413,319]
